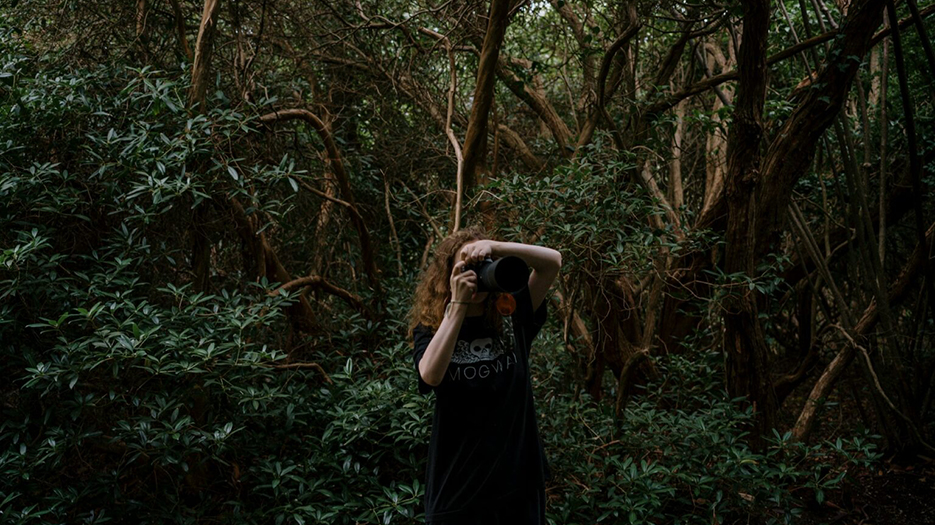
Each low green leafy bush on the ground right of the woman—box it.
[533,330,879,524]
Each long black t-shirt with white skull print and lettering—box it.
[413,287,551,520]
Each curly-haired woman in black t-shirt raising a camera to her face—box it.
[409,227,562,525]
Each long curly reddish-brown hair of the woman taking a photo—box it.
[407,225,502,340]
